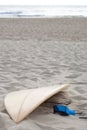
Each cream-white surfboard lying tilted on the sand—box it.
[4,84,69,123]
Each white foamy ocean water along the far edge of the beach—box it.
[0,6,87,18]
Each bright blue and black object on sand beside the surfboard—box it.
[54,104,76,115]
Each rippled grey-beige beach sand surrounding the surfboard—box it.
[0,18,87,130]
